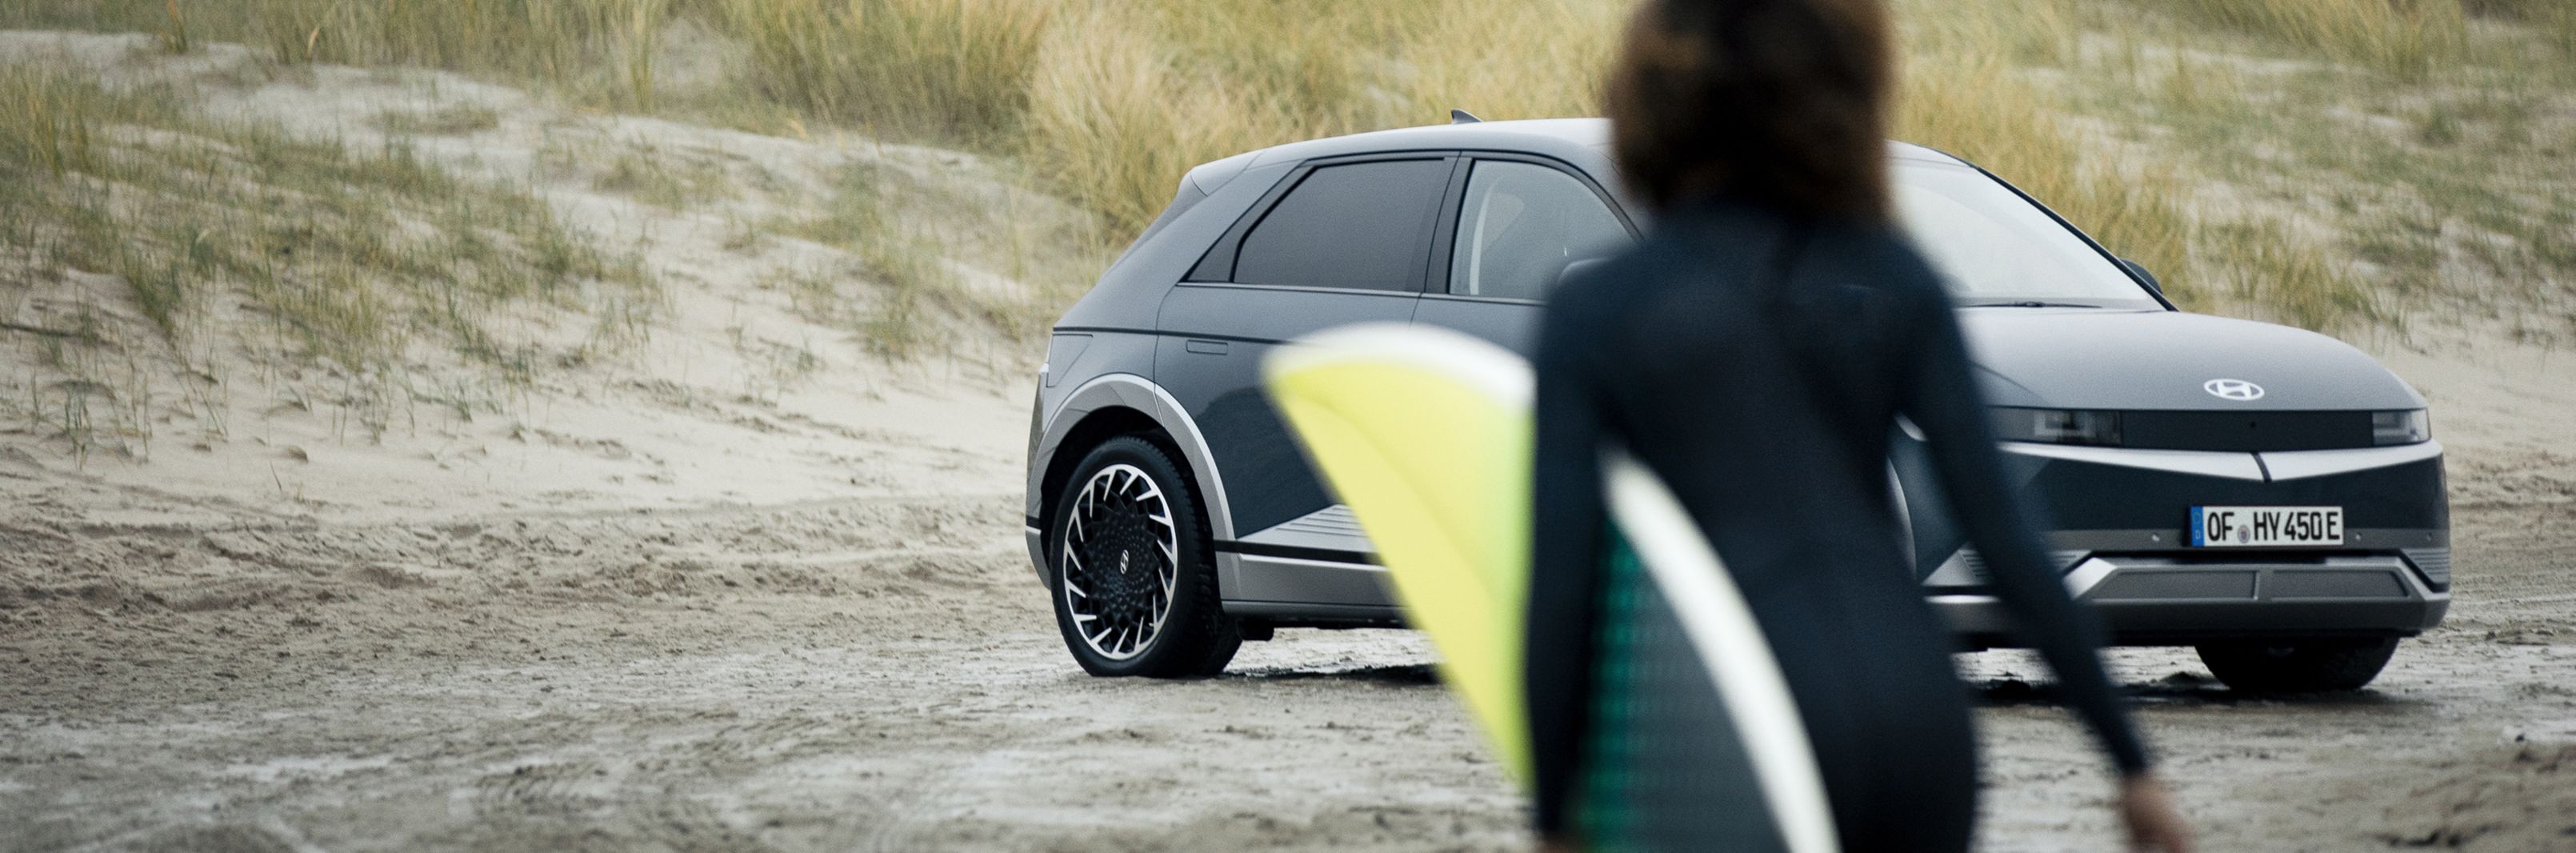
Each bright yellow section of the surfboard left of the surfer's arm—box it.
[1262,322,1533,779]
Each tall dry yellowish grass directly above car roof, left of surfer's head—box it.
[1026,0,1626,234]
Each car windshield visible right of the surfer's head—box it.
[1896,160,2158,309]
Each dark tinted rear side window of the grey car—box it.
[1234,160,1450,291]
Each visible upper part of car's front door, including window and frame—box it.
[1414,154,1636,355]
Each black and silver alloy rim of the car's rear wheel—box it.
[1056,464,1180,659]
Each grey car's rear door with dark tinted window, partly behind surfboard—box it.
[1154,152,1458,606]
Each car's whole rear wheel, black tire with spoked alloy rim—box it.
[1046,435,1244,678]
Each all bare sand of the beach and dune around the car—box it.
[0,34,2576,851]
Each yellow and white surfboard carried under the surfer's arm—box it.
[1262,325,1834,853]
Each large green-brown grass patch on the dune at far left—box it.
[0,65,654,459]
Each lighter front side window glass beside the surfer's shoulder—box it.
[1448,160,1633,299]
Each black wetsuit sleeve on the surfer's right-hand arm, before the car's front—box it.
[1898,270,2146,773]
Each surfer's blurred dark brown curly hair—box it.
[1607,0,1890,222]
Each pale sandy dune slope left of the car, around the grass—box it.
[0,34,1049,518]
